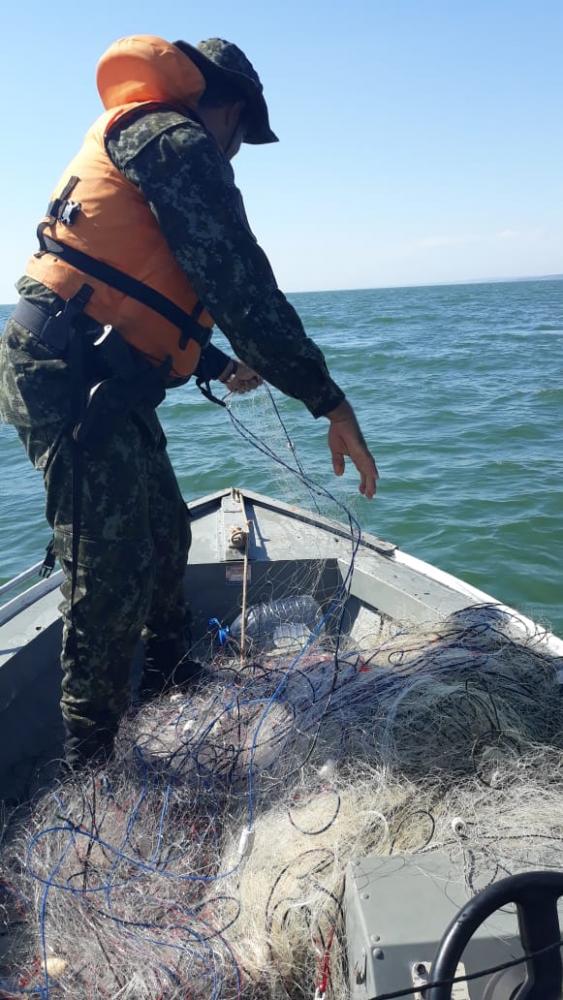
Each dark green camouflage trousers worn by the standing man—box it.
[0,321,191,740]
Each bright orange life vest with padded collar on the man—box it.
[26,35,213,381]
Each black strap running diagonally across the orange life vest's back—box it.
[42,233,210,347]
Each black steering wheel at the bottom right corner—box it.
[425,872,563,1000]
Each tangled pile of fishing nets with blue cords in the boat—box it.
[0,386,563,1000]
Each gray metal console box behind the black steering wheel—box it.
[344,849,523,1000]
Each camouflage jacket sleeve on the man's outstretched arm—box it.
[11,109,344,417]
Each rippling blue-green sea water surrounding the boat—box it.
[0,279,563,634]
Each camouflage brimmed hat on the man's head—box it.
[174,38,278,145]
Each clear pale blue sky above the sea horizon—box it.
[0,0,563,303]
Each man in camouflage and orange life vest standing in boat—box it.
[0,35,377,766]
